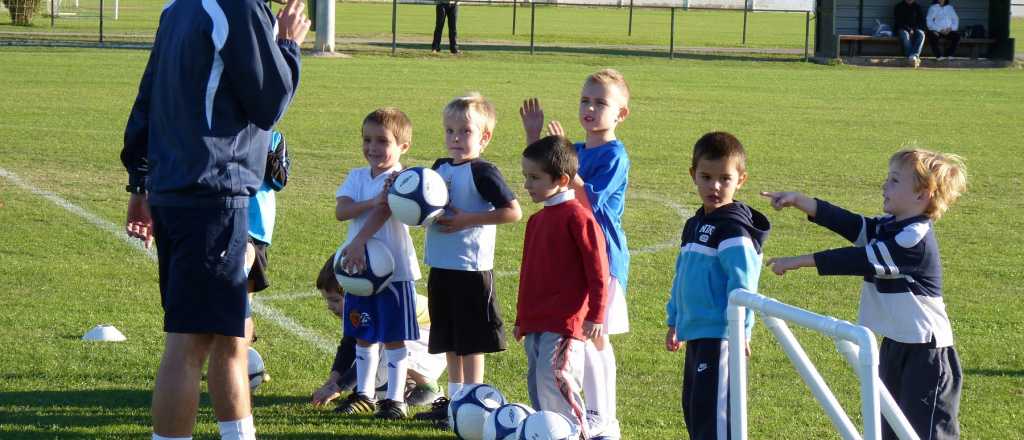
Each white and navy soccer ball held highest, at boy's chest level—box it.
[387,167,447,226]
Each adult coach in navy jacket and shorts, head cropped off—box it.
[121,0,309,439]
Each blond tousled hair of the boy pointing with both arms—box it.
[889,148,967,221]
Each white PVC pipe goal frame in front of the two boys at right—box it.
[727,289,920,440]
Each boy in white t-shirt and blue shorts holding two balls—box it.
[335,107,420,420]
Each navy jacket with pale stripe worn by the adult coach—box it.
[121,0,299,208]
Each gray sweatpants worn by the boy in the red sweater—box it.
[523,333,587,433]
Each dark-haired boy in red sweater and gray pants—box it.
[514,136,608,432]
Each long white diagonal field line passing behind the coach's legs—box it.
[0,168,335,354]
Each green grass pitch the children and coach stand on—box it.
[0,39,1024,439]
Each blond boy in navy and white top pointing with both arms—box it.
[762,149,967,440]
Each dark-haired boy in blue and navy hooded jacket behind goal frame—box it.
[665,132,771,440]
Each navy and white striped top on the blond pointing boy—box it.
[809,201,953,347]
